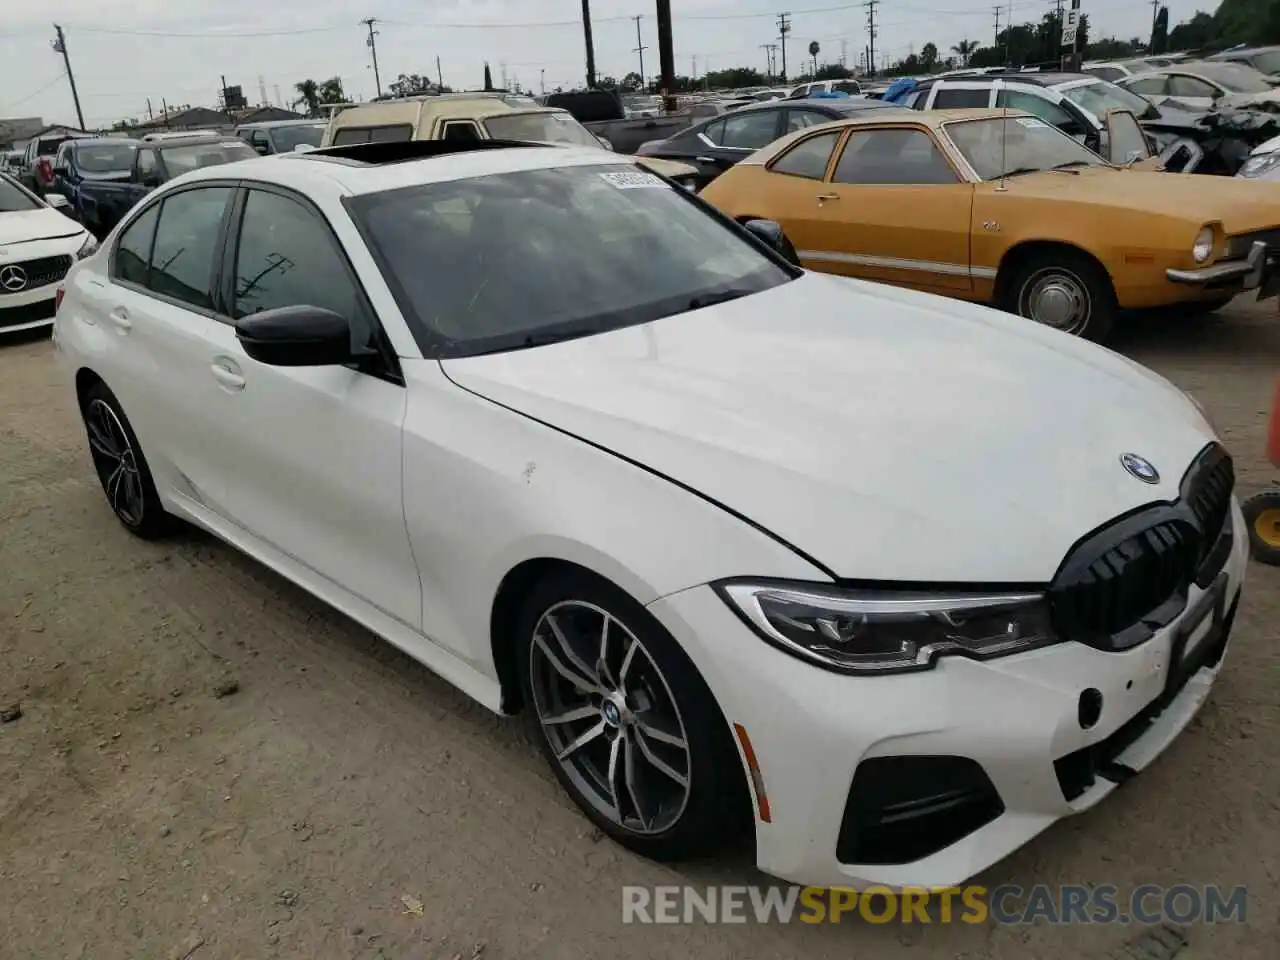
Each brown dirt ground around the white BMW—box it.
[0,302,1280,960]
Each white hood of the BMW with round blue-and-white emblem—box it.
[442,274,1212,582]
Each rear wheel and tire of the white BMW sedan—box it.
[81,381,174,540]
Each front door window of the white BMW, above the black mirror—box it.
[233,189,372,346]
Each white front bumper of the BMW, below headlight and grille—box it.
[649,500,1247,888]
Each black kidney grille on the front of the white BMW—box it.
[1048,444,1235,650]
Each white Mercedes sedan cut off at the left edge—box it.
[0,174,97,337]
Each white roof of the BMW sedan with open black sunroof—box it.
[171,140,636,197]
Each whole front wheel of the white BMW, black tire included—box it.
[517,571,751,861]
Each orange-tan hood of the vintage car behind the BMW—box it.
[988,166,1280,233]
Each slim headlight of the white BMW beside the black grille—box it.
[716,580,1057,675]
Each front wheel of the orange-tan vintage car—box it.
[1001,247,1117,342]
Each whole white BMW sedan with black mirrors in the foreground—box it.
[55,143,1245,886]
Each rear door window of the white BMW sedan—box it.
[147,187,232,310]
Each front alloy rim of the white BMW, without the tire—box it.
[529,600,692,836]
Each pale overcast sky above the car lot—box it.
[0,0,1213,127]
